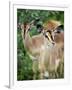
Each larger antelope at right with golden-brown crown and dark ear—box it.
[35,20,64,77]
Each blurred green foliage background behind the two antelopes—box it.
[17,9,64,81]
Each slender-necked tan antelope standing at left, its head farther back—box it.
[21,23,54,79]
